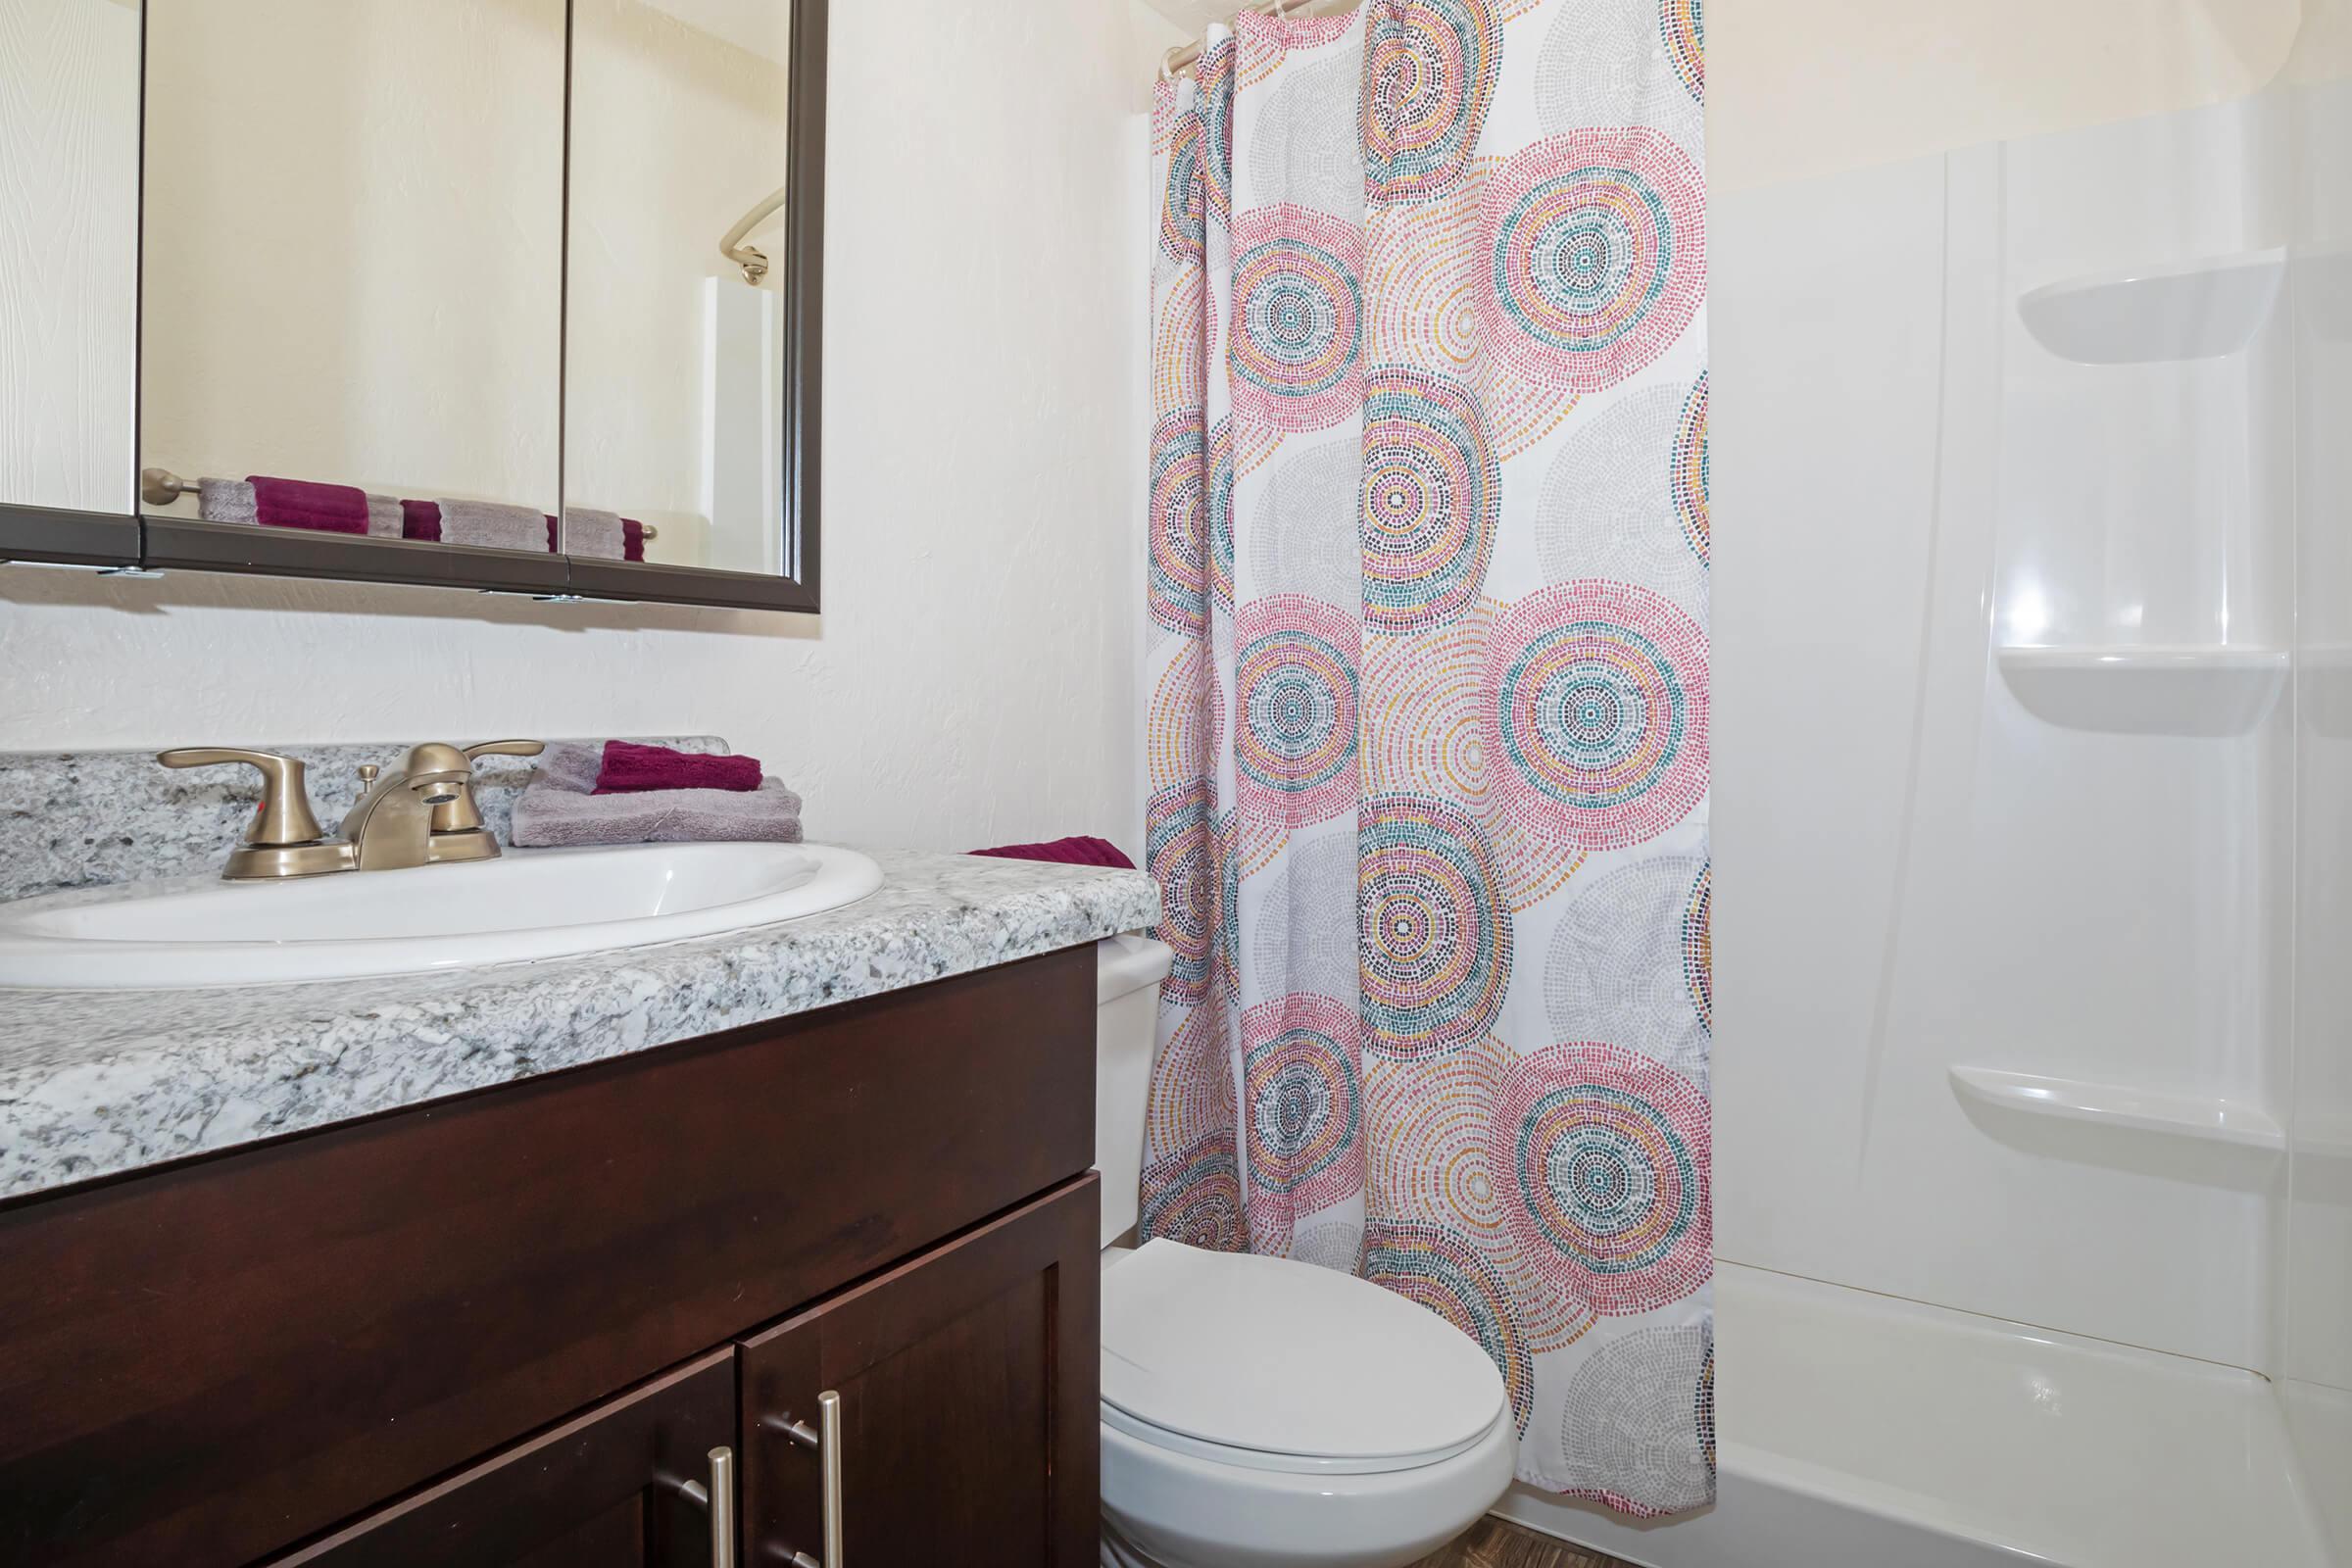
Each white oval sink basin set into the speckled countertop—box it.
[0,844,882,990]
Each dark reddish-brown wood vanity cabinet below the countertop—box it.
[0,948,1099,1568]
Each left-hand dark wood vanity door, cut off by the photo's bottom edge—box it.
[280,1348,736,1568]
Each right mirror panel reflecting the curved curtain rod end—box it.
[564,0,793,573]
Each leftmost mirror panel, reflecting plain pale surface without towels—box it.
[0,0,139,514]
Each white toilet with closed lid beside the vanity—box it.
[1094,936,1519,1568]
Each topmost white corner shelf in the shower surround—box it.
[2018,247,2286,365]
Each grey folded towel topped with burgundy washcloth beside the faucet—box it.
[515,741,800,849]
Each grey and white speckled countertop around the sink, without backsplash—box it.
[0,851,1159,1197]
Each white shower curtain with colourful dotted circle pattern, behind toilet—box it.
[1141,0,1715,1514]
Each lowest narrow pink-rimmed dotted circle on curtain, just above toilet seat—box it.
[1242,995,1364,1213]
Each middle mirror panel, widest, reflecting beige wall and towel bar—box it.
[139,0,564,553]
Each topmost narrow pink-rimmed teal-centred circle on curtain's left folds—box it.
[1228,207,1364,430]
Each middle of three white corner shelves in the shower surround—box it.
[1994,644,2286,736]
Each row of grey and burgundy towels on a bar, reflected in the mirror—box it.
[195,475,645,562]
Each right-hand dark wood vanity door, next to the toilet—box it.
[743,1175,1101,1568]
